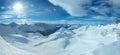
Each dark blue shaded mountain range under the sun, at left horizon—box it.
[0,23,59,36]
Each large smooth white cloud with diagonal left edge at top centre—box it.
[49,0,90,16]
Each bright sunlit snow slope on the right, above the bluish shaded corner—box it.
[63,24,120,55]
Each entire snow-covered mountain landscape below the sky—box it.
[0,23,120,55]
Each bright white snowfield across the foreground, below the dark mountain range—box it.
[0,24,120,55]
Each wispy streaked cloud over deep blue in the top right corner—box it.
[90,0,120,16]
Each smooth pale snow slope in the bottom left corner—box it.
[0,37,33,55]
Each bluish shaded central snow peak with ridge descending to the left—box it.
[35,27,74,47]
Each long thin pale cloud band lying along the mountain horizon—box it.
[0,19,106,25]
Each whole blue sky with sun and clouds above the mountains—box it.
[0,0,120,24]
